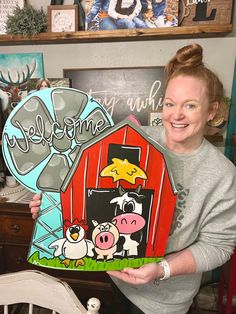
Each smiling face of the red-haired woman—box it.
[162,76,214,153]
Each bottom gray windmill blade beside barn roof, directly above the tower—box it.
[36,154,70,192]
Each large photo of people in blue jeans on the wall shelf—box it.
[84,0,179,31]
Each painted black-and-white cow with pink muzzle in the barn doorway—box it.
[110,186,145,258]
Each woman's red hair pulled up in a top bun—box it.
[165,43,224,106]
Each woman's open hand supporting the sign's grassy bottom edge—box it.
[107,263,163,285]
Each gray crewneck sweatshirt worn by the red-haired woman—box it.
[112,127,236,314]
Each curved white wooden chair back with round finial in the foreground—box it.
[0,270,100,314]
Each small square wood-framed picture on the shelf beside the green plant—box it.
[48,5,78,33]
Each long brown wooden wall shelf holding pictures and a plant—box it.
[0,24,233,46]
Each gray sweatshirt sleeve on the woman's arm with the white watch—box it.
[188,166,236,272]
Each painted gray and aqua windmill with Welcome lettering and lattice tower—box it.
[0,88,113,268]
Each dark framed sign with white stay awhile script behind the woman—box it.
[63,66,164,125]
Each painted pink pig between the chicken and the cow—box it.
[92,220,119,262]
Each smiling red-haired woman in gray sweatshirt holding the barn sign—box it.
[30,44,236,314]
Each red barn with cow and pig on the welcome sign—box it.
[58,120,177,270]
